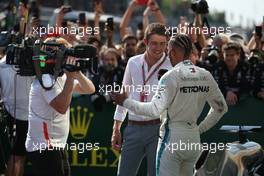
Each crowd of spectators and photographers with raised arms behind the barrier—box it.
[1,0,264,111]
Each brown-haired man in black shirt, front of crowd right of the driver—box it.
[213,42,250,105]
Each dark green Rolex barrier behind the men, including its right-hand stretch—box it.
[23,96,264,176]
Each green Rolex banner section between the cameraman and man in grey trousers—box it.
[68,96,119,176]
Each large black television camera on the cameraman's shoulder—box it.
[6,39,97,76]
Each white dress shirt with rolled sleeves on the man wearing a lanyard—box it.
[114,53,172,121]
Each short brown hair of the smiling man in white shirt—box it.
[144,23,167,40]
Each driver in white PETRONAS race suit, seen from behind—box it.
[112,34,227,176]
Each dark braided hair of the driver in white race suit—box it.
[169,34,193,59]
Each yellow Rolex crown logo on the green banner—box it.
[70,106,94,139]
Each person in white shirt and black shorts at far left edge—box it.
[0,53,33,176]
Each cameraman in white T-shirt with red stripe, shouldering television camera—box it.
[26,38,95,176]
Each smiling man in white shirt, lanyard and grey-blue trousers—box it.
[112,23,171,176]
